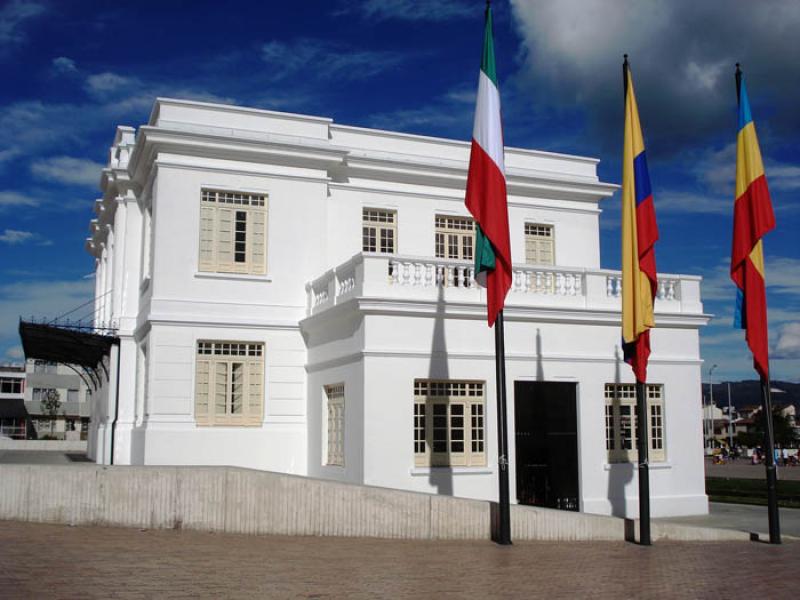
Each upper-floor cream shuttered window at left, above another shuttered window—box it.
[200,189,267,275]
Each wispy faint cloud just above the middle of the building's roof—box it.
[261,38,403,80]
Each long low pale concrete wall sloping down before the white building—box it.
[0,464,748,540]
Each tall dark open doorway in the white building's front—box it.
[514,381,579,511]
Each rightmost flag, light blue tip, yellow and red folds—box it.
[731,67,775,379]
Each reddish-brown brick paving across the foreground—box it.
[0,521,800,599]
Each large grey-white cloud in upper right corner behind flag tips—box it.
[511,0,800,155]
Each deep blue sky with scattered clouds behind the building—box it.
[0,0,800,381]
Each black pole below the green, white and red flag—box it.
[494,310,511,546]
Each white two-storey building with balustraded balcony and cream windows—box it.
[87,99,709,516]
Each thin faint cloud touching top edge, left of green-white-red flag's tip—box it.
[337,0,472,21]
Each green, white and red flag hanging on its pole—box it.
[466,1,511,327]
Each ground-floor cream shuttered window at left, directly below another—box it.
[195,340,264,427]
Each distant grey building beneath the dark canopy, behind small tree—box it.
[25,360,91,440]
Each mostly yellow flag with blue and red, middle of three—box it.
[622,59,658,382]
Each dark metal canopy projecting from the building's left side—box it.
[19,321,119,389]
